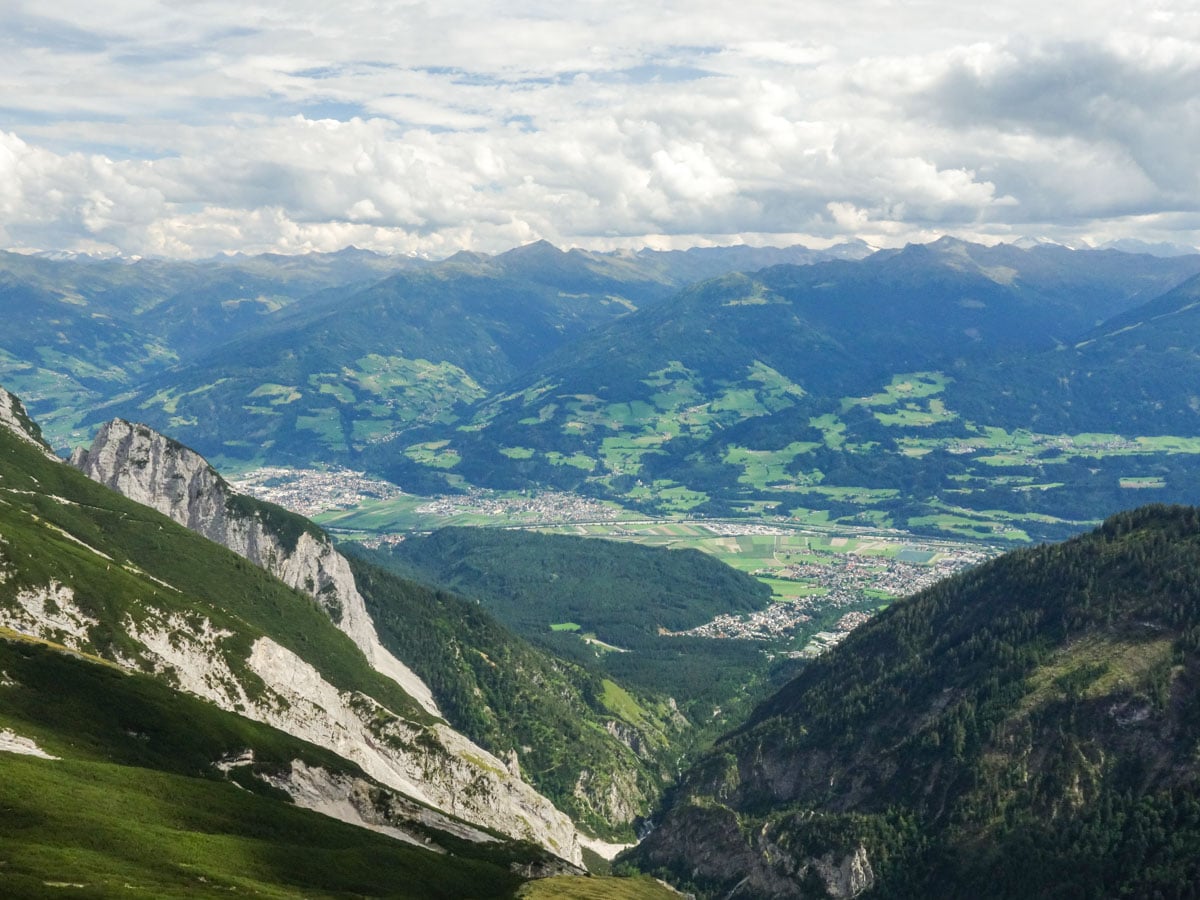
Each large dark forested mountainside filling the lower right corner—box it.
[632,506,1200,898]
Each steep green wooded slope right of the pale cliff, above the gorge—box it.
[348,548,694,841]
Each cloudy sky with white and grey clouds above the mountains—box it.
[0,0,1200,258]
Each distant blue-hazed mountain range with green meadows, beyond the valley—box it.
[7,239,1200,540]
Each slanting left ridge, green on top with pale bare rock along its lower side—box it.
[0,398,580,863]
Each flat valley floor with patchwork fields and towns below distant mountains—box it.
[229,468,1000,655]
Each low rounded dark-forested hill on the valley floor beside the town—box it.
[360,528,770,725]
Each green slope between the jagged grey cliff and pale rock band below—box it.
[0,430,430,721]
